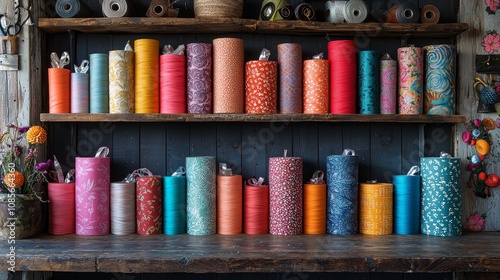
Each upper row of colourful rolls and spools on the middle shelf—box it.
[49,38,456,115]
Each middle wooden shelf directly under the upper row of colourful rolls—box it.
[40,113,466,123]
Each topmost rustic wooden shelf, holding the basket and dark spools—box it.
[38,17,469,38]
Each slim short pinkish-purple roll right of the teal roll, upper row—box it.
[380,54,398,114]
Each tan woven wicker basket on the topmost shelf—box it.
[194,0,243,18]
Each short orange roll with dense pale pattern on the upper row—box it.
[245,60,278,114]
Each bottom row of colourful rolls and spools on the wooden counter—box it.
[48,153,462,236]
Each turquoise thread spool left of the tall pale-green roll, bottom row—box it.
[163,176,186,235]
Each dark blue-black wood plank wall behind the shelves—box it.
[43,0,458,280]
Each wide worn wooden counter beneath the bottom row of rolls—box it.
[6,232,500,273]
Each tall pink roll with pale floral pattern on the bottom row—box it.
[75,157,110,235]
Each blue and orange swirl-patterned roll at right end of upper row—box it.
[424,45,457,115]
